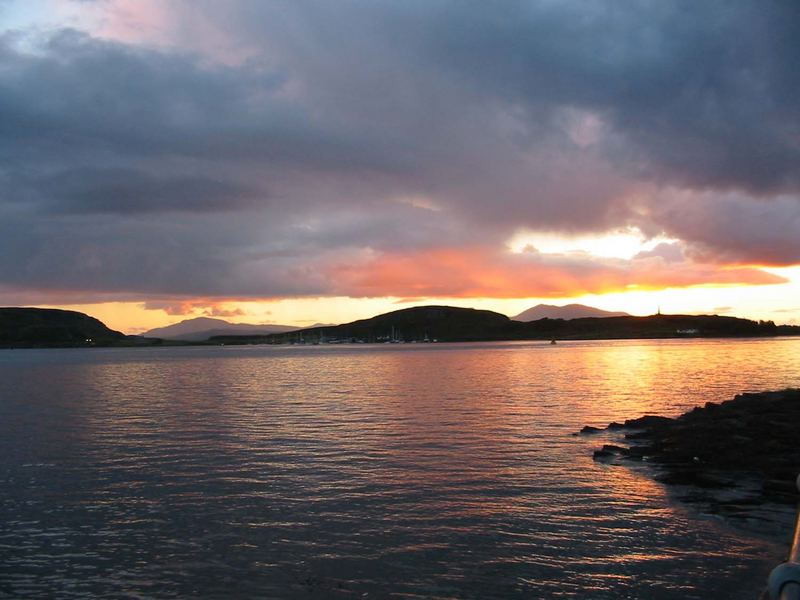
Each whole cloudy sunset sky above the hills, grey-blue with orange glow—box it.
[0,0,800,333]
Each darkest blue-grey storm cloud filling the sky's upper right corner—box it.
[412,1,800,193]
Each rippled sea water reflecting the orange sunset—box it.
[0,339,800,600]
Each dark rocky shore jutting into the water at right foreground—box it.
[580,389,800,528]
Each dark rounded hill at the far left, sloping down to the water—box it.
[0,308,127,347]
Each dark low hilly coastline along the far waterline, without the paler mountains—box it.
[7,306,800,348]
